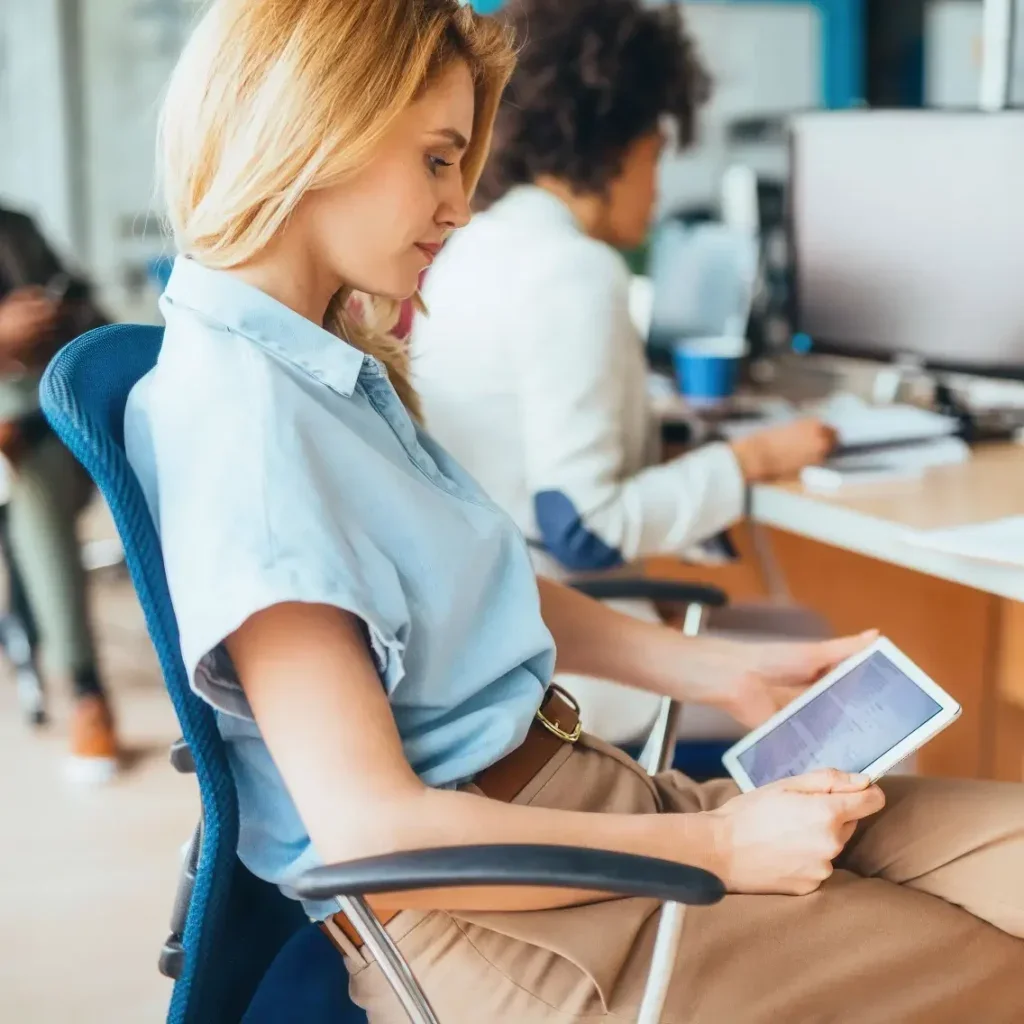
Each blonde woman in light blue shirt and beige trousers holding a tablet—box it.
[125,0,1024,1024]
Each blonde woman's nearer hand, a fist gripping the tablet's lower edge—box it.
[708,769,885,896]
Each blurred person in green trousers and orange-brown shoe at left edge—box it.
[0,207,118,781]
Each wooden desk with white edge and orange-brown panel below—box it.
[657,444,1024,780]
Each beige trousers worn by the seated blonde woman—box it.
[347,736,1024,1024]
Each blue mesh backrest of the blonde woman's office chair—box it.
[41,325,327,1024]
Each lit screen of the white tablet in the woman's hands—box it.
[737,651,942,786]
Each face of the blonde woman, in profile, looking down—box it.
[293,62,473,299]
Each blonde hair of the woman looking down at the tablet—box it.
[158,0,514,414]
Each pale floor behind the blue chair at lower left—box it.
[0,557,199,1024]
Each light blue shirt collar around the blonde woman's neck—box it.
[161,256,366,396]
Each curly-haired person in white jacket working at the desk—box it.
[412,0,835,742]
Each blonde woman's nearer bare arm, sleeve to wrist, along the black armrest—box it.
[227,604,717,910]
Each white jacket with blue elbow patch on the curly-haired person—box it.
[411,186,744,740]
